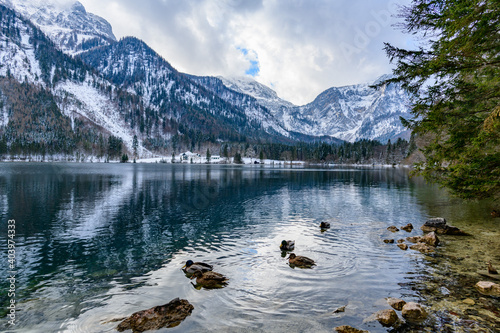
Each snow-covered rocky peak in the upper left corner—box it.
[0,0,116,54]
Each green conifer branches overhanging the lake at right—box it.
[385,0,500,199]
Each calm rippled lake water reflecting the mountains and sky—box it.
[0,163,500,333]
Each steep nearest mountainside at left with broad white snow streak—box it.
[0,5,146,151]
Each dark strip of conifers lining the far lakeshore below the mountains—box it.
[0,130,416,164]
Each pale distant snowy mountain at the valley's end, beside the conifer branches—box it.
[218,76,409,142]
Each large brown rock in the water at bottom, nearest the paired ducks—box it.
[116,298,194,333]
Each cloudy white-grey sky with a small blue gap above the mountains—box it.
[75,0,411,105]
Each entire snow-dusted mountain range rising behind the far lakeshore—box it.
[0,0,409,161]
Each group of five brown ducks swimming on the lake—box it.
[182,222,330,289]
